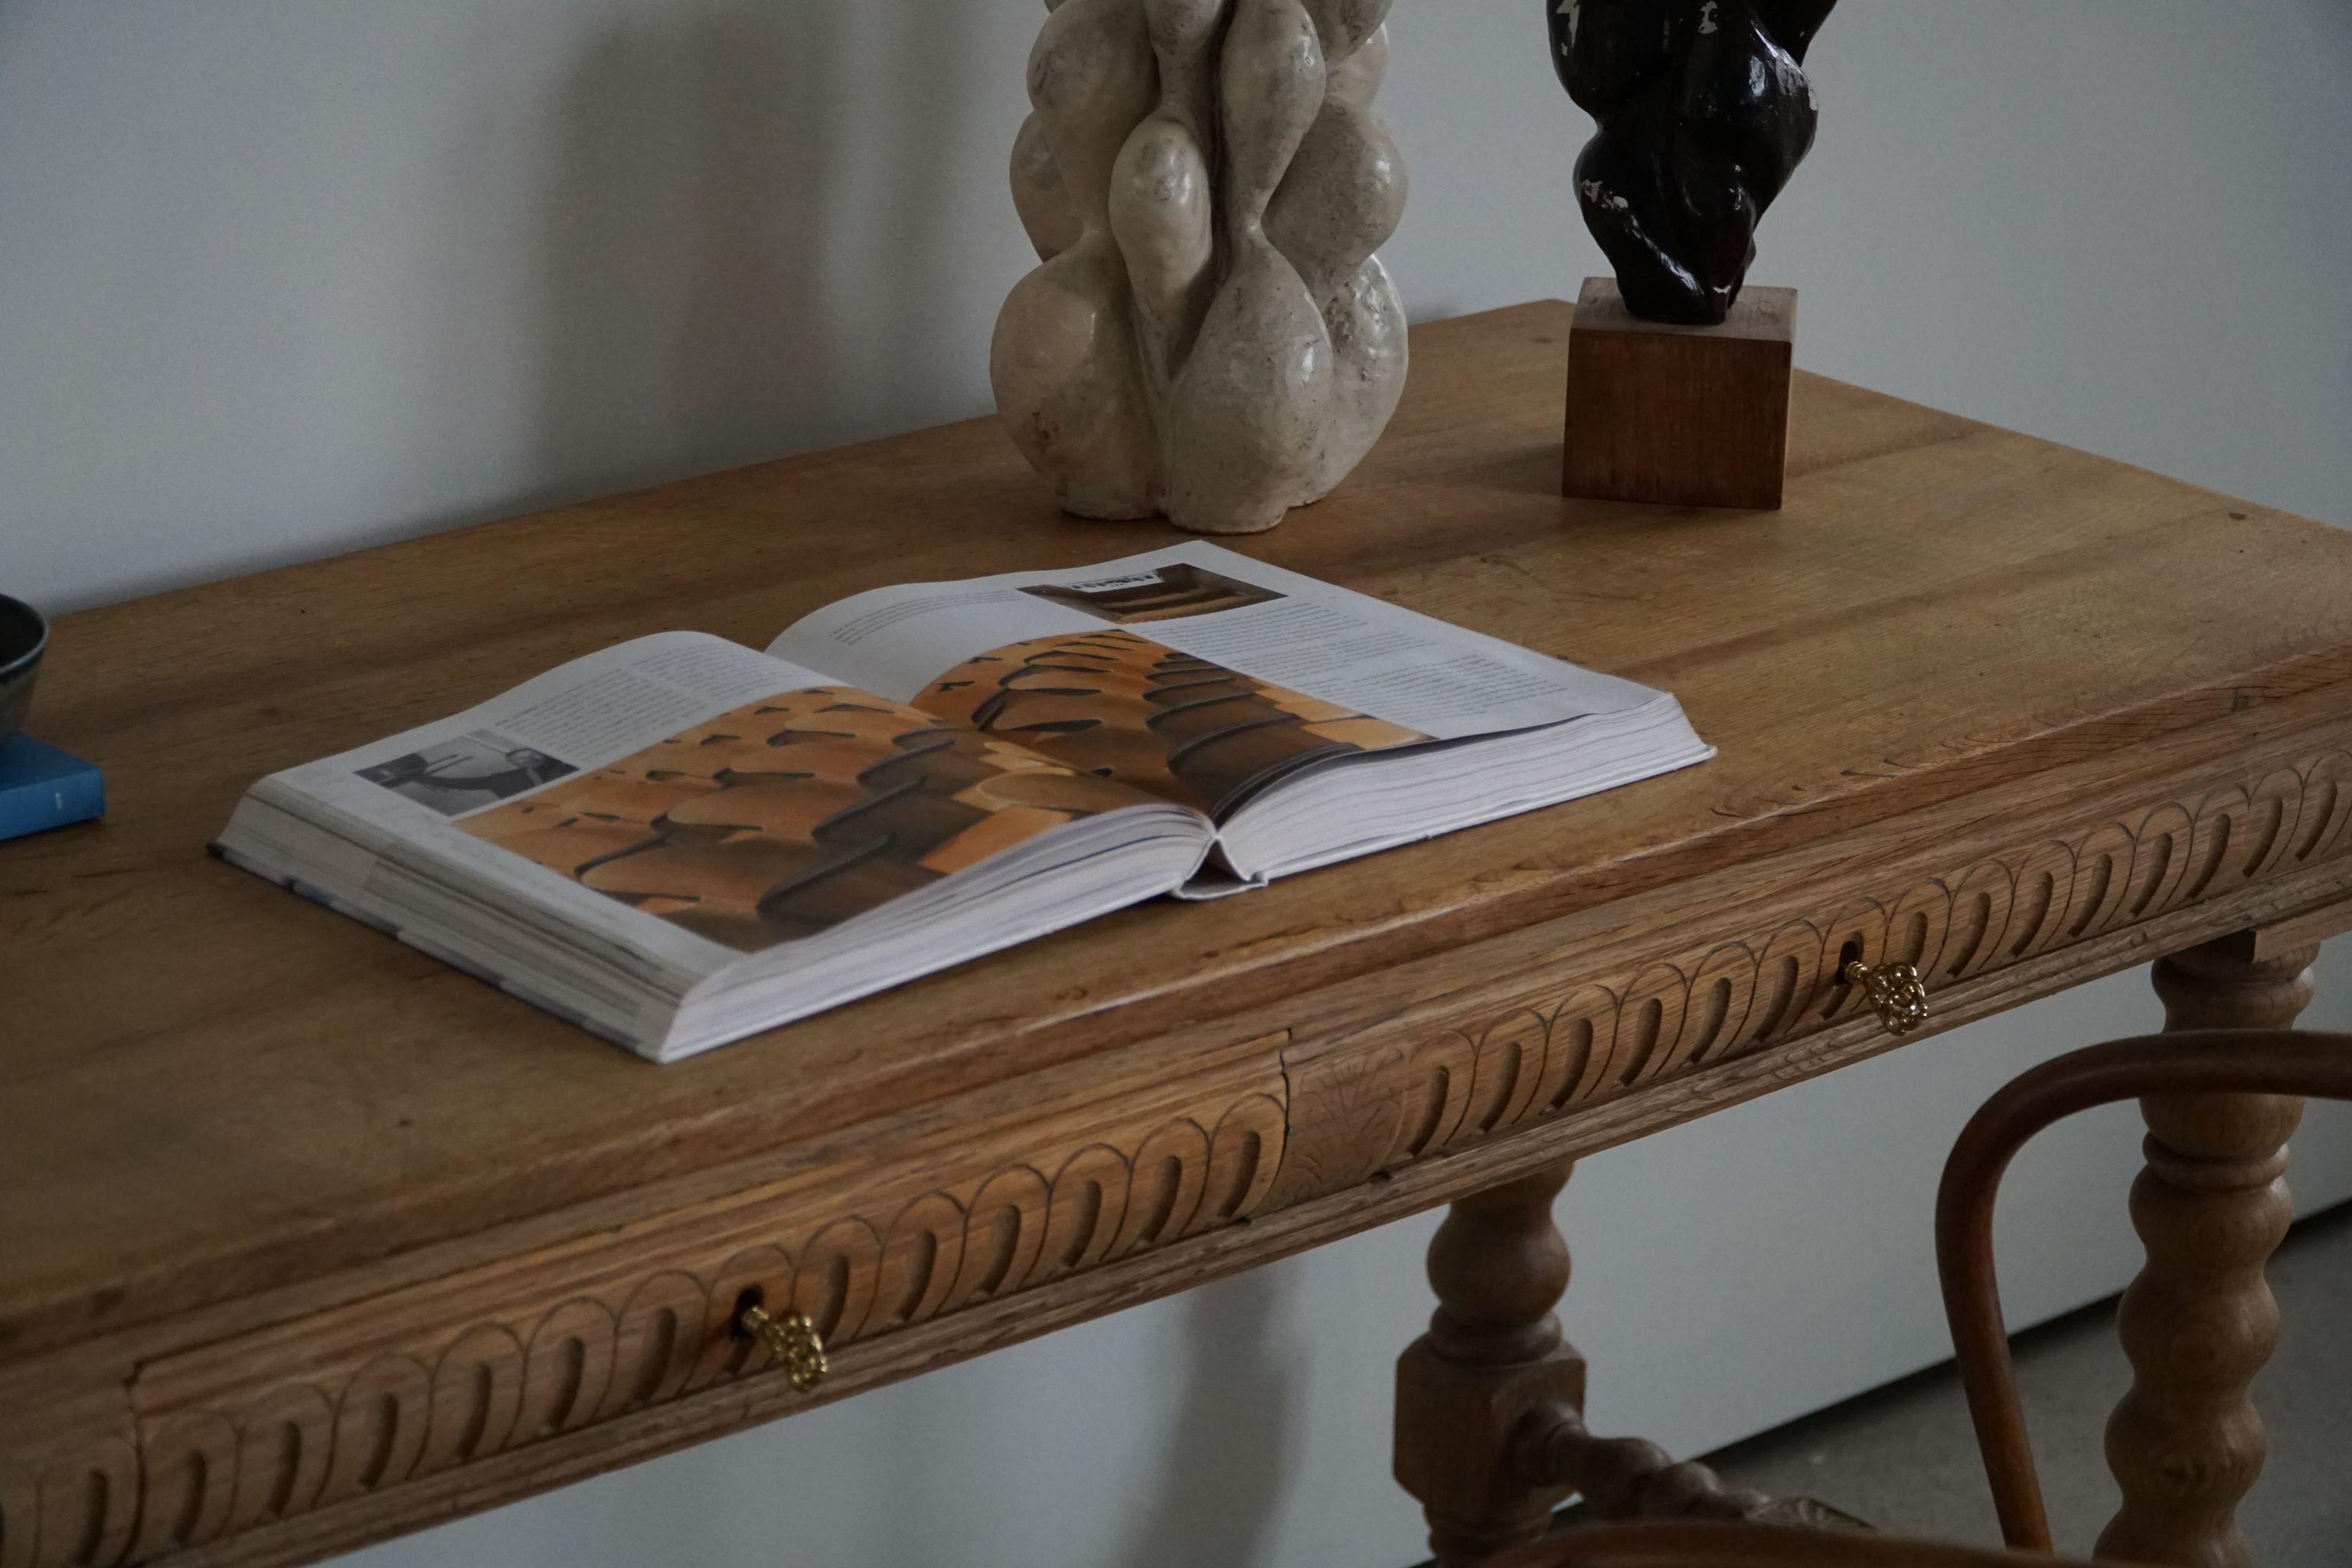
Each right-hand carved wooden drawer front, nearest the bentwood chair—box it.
[1268,724,2352,1208]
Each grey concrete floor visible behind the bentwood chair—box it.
[1710,1208,2352,1568]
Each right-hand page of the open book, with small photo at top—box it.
[769,543,1658,813]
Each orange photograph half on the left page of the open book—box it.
[459,687,1136,952]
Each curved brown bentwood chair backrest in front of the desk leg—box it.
[1929,1030,2352,1568]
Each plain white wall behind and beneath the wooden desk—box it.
[0,0,2352,1568]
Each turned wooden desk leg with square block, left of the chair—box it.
[1397,1166,1586,1568]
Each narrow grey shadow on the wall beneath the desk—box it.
[1106,1269,1308,1568]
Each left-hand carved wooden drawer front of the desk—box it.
[106,1039,1286,1568]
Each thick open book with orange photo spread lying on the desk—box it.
[217,543,1714,1060]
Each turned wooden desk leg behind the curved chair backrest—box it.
[2098,933,2319,1568]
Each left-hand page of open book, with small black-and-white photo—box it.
[259,632,1155,969]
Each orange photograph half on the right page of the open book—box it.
[915,628,1428,813]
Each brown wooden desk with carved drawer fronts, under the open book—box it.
[0,303,2352,1568]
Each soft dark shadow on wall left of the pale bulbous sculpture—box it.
[529,0,988,510]
